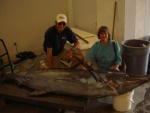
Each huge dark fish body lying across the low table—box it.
[2,68,150,98]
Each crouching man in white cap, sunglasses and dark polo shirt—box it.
[43,14,84,68]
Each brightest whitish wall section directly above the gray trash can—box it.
[124,0,150,40]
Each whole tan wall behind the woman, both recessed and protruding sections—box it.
[72,0,125,42]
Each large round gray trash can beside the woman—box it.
[122,39,150,75]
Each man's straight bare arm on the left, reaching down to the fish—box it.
[47,48,54,68]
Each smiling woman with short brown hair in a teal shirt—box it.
[82,26,122,70]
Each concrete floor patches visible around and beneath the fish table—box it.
[0,51,150,113]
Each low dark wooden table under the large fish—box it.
[0,83,87,112]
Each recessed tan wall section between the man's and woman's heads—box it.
[72,0,97,33]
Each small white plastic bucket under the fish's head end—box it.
[113,90,134,112]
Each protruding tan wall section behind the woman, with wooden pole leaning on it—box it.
[97,0,125,42]
